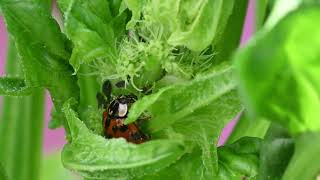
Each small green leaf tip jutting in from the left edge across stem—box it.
[0,77,33,96]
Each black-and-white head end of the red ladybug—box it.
[109,95,137,118]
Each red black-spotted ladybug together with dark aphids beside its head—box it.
[97,81,148,144]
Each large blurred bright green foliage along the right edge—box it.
[235,4,320,179]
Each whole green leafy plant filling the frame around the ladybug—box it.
[0,0,320,179]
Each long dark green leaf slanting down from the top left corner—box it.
[0,0,79,131]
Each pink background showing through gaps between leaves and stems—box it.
[0,0,255,153]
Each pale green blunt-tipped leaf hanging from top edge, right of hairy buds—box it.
[168,0,224,51]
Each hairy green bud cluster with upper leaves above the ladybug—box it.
[58,0,247,90]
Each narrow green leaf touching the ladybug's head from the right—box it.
[125,64,236,128]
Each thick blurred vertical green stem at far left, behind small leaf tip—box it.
[0,38,44,180]
